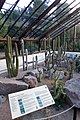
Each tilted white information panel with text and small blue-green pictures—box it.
[8,85,55,119]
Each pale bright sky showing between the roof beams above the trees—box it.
[1,0,80,13]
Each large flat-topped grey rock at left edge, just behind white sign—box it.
[0,78,28,95]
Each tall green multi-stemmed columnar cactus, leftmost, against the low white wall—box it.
[5,36,19,77]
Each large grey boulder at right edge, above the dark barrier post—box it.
[64,78,80,108]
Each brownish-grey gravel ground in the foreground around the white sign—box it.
[0,95,80,120]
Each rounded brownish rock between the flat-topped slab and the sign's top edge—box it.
[23,75,38,88]
